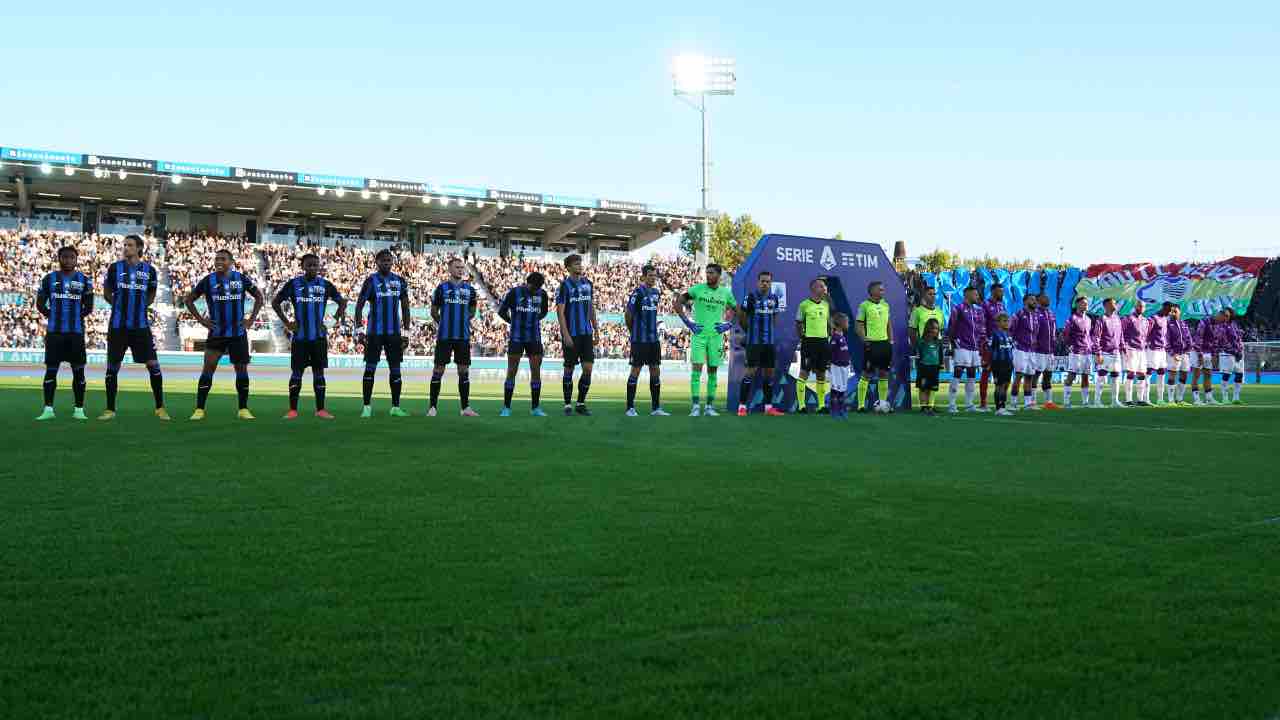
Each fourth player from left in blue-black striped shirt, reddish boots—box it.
[271,252,347,420]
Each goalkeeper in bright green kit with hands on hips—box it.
[676,263,737,418]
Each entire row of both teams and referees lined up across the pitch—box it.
[30,236,1243,420]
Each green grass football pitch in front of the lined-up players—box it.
[0,372,1280,719]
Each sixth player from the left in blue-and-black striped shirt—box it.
[426,258,479,418]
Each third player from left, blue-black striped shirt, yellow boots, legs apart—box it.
[182,250,266,420]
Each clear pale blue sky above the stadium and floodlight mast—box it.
[0,0,1280,261]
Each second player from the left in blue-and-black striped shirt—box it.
[97,234,170,420]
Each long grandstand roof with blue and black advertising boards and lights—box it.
[0,146,698,250]
